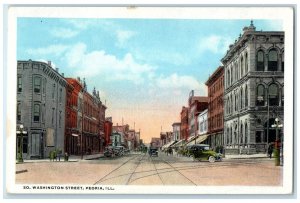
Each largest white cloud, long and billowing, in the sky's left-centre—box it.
[65,43,155,84]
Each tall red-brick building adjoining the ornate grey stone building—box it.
[205,66,224,148]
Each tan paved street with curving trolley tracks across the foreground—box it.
[16,152,282,186]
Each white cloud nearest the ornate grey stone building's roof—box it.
[198,35,232,53]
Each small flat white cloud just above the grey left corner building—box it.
[26,44,68,56]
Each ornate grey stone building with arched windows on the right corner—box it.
[221,21,284,154]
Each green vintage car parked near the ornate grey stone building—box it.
[189,144,222,162]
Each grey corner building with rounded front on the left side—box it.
[17,60,67,159]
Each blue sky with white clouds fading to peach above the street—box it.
[17,18,283,141]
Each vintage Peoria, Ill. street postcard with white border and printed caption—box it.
[4,6,295,194]
